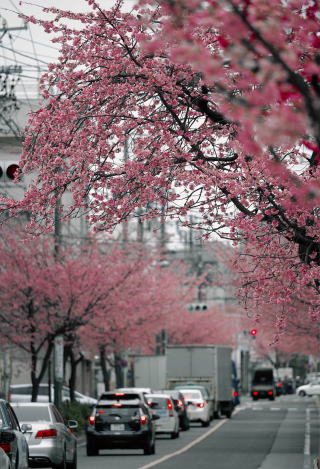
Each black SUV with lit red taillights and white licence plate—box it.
[86,392,158,456]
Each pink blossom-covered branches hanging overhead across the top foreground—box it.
[2,0,320,328]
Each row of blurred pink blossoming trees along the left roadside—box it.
[0,230,241,400]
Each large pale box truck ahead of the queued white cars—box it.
[166,345,234,418]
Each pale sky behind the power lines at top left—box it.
[0,0,134,99]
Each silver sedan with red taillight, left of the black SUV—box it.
[12,402,78,469]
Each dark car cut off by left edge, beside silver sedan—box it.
[0,399,30,469]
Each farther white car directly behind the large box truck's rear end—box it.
[180,388,211,427]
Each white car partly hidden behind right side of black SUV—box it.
[146,393,179,439]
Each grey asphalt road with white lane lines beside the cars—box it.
[74,396,320,469]
